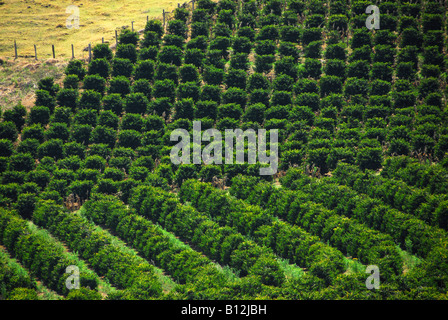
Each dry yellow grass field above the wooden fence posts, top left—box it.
[0,0,184,59]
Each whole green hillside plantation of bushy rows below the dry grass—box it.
[0,0,448,299]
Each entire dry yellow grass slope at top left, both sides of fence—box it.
[0,0,184,110]
